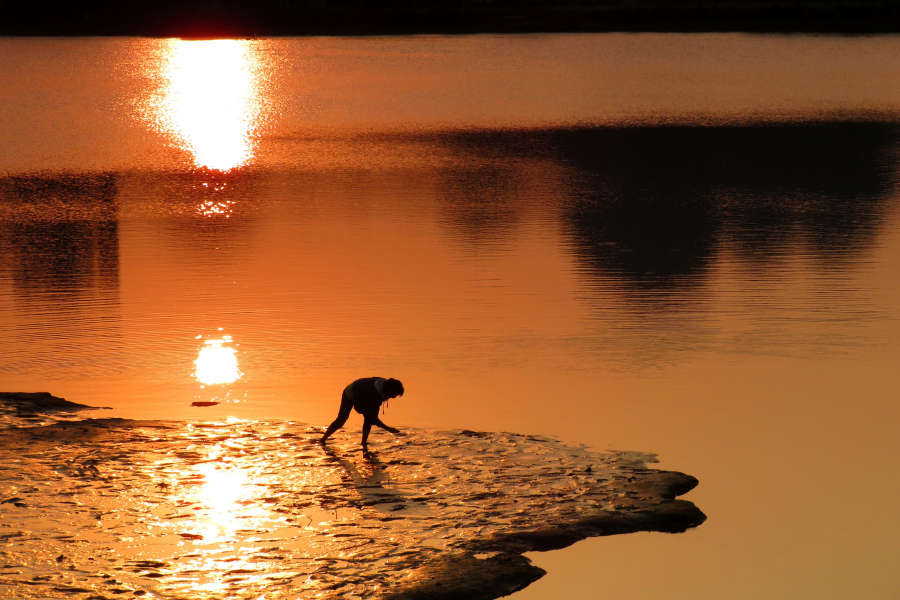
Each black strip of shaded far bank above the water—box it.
[0,0,900,38]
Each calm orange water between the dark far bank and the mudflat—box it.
[0,35,900,600]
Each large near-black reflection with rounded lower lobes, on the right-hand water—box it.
[553,123,898,289]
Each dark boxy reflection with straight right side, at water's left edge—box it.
[0,174,119,298]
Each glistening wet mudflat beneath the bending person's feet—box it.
[0,394,705,600]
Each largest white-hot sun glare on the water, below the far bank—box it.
[156,40,261,171]
